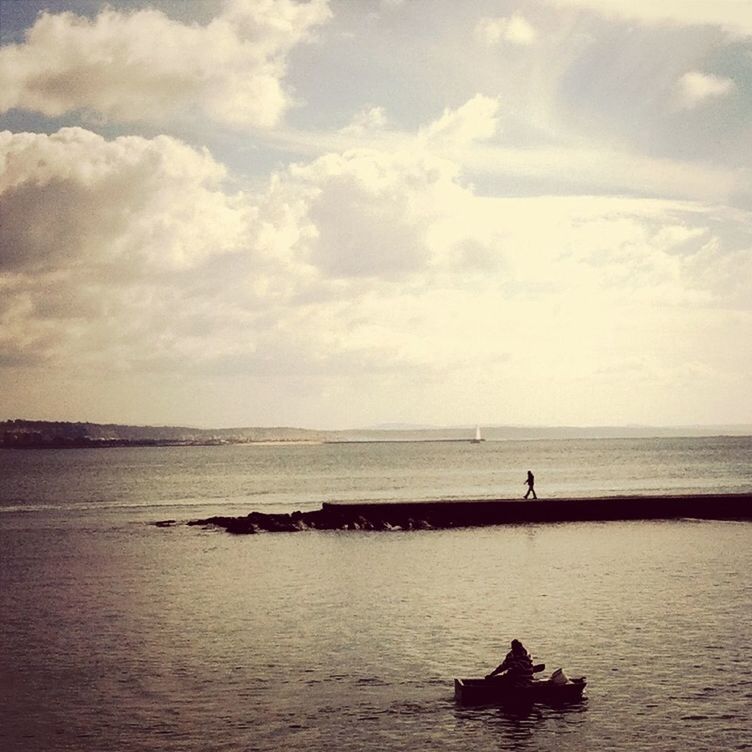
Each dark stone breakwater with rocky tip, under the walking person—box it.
[182,494,752,534]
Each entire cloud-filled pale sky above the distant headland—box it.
[0,0,752,428]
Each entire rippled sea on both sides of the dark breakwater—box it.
[0,436,752,752]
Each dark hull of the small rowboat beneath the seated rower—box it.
[454,676,587,705]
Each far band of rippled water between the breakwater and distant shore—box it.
[0,436,752,524]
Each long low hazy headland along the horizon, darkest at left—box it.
[0,419,752,449]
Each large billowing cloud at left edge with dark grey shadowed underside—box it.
[0,128,252,368]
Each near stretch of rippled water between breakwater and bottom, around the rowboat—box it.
[0,522,752,752]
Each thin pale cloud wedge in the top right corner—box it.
[549,0,752,35]
